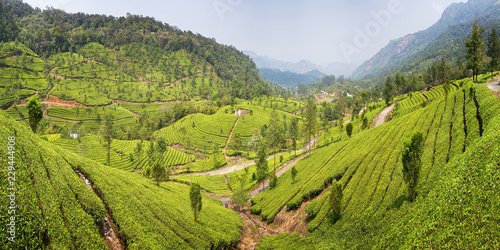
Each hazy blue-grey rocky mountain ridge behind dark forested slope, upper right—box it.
[352,0,498,79]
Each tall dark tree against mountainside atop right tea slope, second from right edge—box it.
[465,21,484,82]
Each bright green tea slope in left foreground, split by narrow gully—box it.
[0,111,242,249]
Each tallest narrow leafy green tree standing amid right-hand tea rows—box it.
[401,131,424,202]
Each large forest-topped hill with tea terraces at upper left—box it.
[0,0,271,106]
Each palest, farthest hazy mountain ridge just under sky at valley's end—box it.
[243,50,357,76]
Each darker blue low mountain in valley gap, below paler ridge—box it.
[259,68,326,89]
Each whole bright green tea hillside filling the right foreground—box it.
[252,80,500,249]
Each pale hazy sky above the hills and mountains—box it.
[25,0,466,64]
